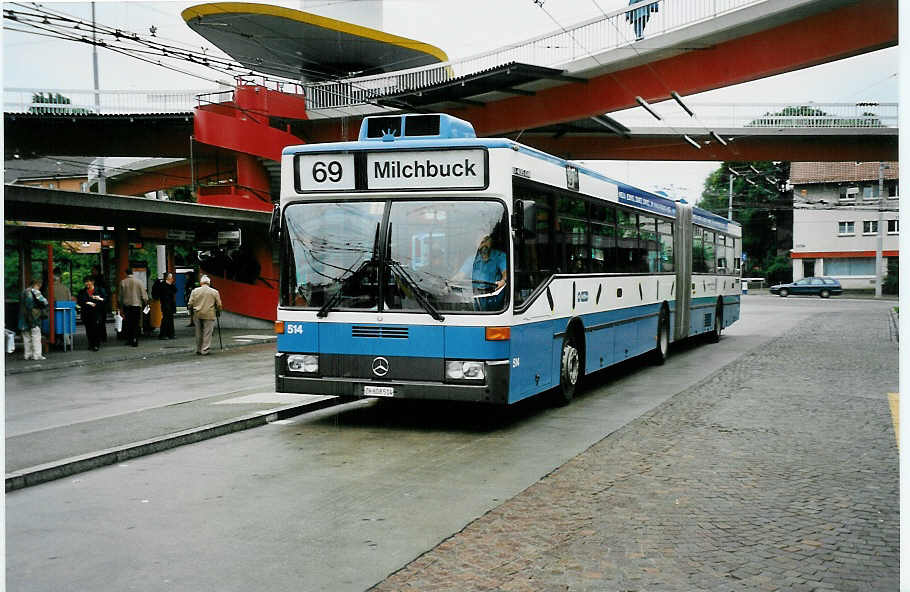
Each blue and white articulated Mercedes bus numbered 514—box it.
[272,114,742,404]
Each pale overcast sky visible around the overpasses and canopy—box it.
[2,0,899,201]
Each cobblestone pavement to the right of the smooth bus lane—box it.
[373,309,899,592]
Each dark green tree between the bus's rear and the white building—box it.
[698,161,793,279]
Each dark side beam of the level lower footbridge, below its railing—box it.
[4,113,898,162]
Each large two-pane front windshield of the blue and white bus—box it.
[282,200,510,316]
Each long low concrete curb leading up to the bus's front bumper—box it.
[6,397,343,492]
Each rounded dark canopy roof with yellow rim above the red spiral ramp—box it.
[181,2,448,80]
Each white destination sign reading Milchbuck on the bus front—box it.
[367,149,487,189]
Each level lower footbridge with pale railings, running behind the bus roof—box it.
[4,97,898,162]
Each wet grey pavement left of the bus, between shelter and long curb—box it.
[5,317,335,491]
